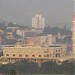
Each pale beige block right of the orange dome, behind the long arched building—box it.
[37,34,56,46]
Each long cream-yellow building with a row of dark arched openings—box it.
[1,44,66,63]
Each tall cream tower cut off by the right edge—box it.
[72,15,75,59]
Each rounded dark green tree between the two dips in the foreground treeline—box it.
[41,61,59,74]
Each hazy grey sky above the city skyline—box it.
[0,0,74,25]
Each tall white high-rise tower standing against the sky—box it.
[32,14,45,29]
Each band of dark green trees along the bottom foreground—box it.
[0,60,75,75]
